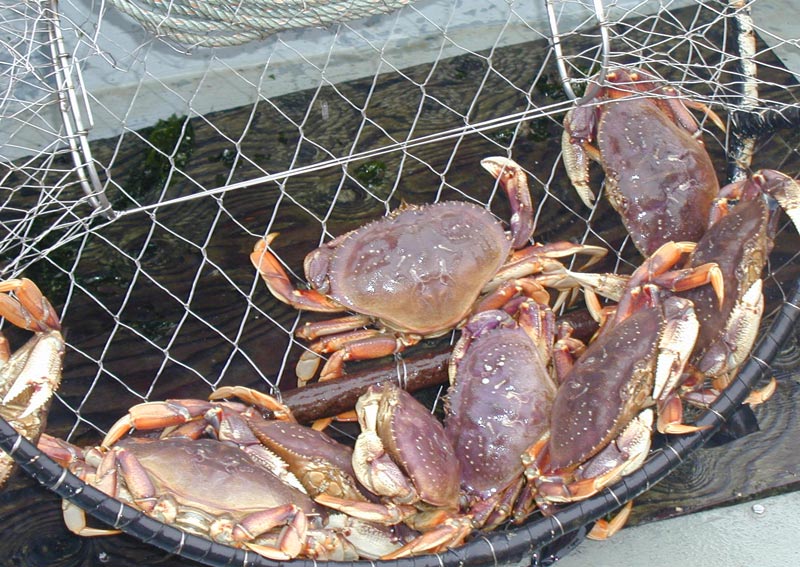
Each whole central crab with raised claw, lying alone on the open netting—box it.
[251,157,606,383]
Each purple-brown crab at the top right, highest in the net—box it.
[562,68,724,256]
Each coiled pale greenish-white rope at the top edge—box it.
[109,0,411,47]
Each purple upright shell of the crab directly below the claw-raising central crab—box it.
[444,306,556,508]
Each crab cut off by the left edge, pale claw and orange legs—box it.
[0,278,64,486]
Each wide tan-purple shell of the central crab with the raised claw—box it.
[305,201,511,336]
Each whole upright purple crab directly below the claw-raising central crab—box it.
[444,300,584,529]
